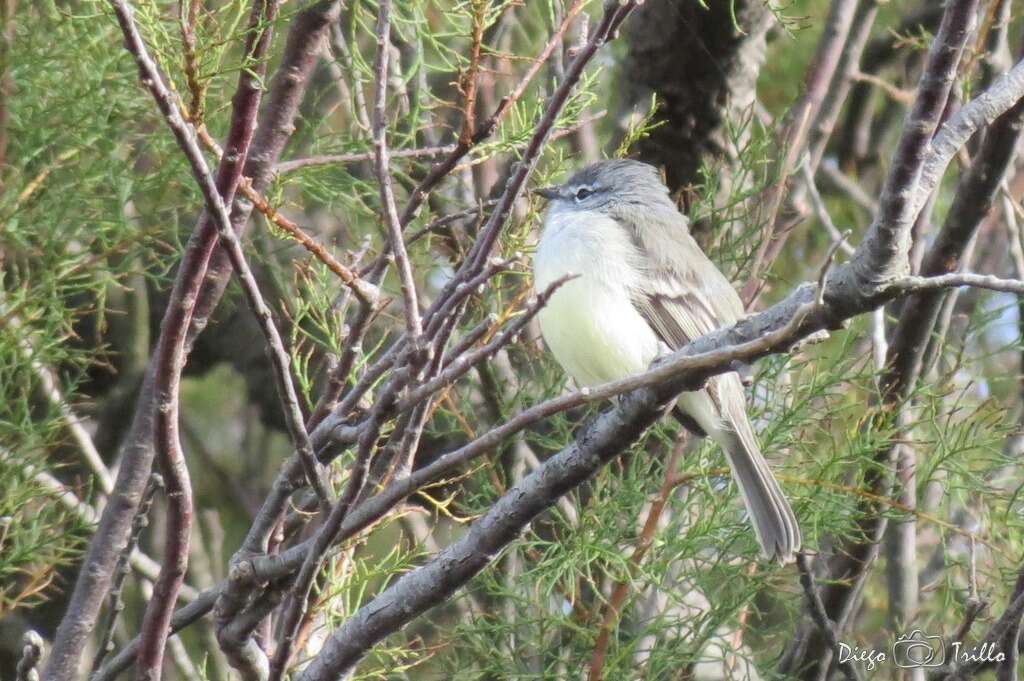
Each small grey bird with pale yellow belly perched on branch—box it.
[534,161,801,562]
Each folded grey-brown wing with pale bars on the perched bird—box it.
[624,208,743,350]
